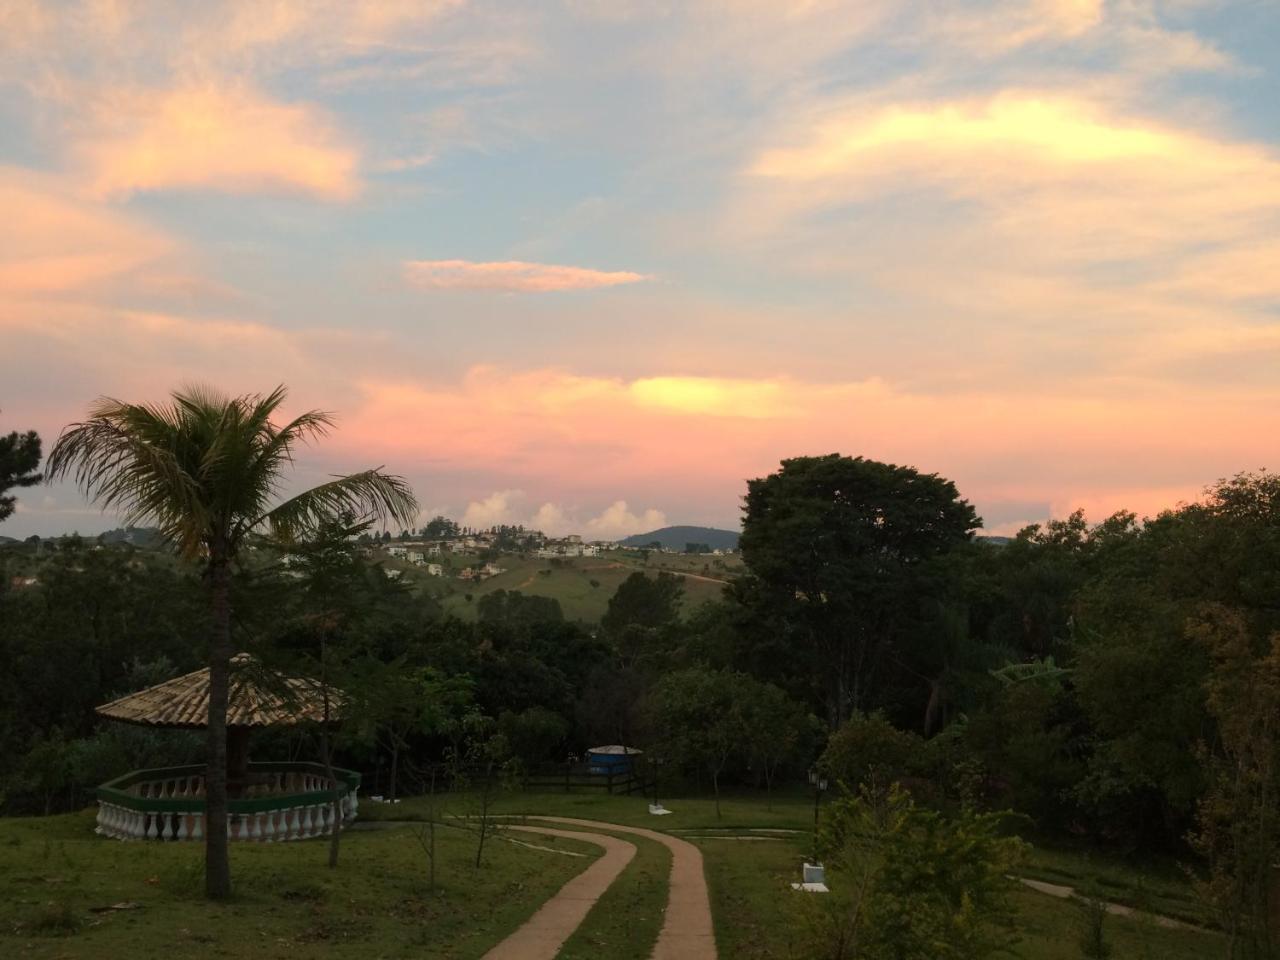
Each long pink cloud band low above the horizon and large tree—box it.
[334,367,1280,538]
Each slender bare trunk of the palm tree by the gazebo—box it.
[205,557,232,900]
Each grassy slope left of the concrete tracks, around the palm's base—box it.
[0,812,599,960]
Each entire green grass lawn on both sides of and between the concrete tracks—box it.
[0,791,1224,960]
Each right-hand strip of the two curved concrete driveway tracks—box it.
[519,817,717,960]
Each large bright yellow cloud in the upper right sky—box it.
[742,90,1280,274]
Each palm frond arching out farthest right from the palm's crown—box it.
[257,467,419,541]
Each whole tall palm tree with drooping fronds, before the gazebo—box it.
[46,387,417,899]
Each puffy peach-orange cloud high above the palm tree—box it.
[78,84,360,200]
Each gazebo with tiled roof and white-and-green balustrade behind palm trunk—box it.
[97,653,360,842]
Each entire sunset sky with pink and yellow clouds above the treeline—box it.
[0,0,1280,539]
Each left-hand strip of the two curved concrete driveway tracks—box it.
[484,826,636,960]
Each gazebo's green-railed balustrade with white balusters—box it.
[97,763,360,842]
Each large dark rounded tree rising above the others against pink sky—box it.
[735,453,980,727]
